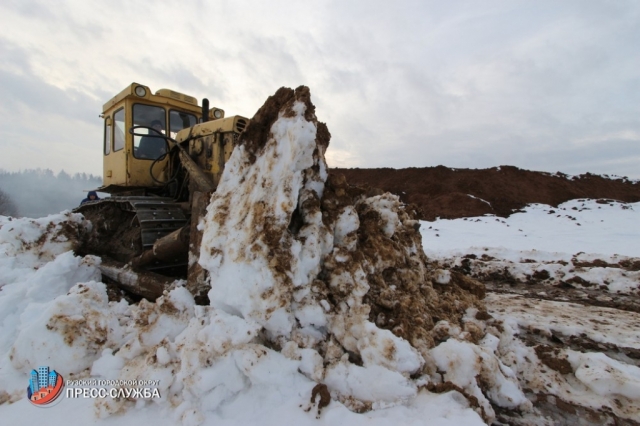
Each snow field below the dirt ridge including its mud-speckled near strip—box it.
[421,200,640,297]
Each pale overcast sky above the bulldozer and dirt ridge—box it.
[0,0,640,178]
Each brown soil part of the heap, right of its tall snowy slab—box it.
[318,175,485,356]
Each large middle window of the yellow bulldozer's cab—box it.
[133,104,167,160]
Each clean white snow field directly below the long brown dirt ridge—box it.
[421,199,640,260]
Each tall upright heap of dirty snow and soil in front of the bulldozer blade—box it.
[200,87,498,416]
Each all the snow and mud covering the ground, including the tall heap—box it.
[0,87,640,425]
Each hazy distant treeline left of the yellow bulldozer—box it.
[0,169,102,218]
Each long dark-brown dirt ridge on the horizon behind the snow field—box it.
[331,166,640,220]
